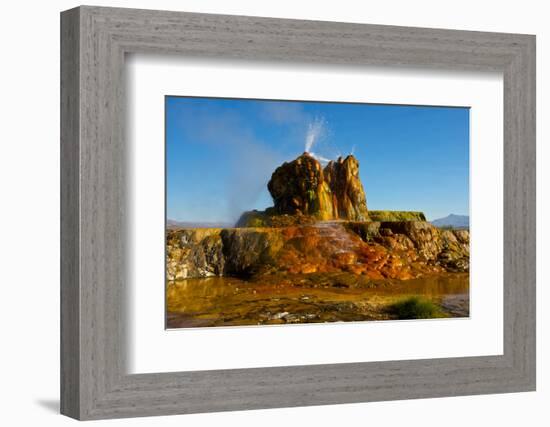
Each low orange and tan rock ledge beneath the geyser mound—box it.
[167,221,469,280]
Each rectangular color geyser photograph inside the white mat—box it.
[165,96,470,329]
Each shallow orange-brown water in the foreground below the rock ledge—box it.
[166,273,469,328]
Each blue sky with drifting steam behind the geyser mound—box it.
[166,97,470,222]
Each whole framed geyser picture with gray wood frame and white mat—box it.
[61,6,535,419]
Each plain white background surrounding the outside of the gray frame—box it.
[0,0,550,427]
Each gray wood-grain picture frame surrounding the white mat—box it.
[61,6,535,420]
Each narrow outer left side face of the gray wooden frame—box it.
[60,9,80,417]
